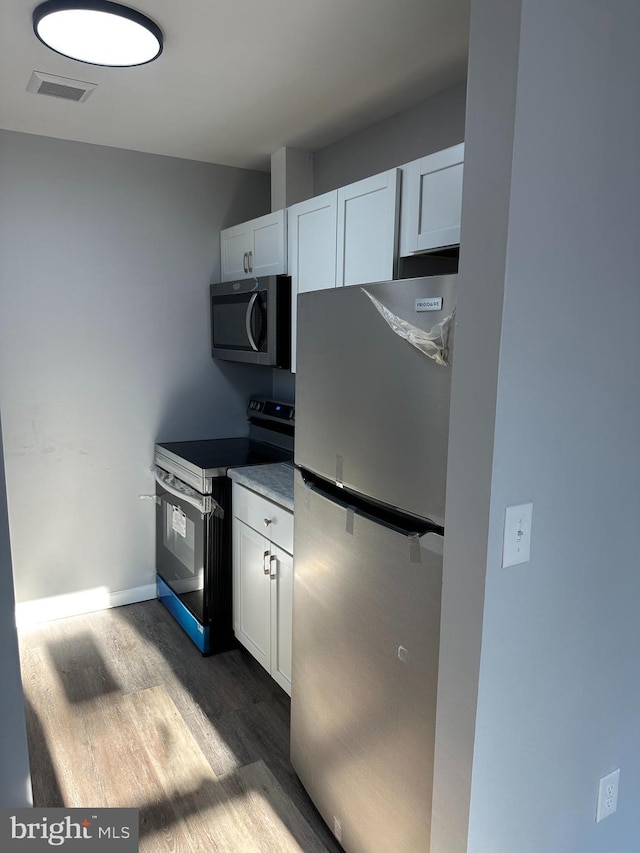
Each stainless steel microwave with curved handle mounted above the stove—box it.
[210,275,291,370]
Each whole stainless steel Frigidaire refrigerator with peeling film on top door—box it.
[291,275,456,853]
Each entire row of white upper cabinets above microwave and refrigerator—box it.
[220,143,464,373]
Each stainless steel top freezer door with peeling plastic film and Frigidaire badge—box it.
[295,275,456,525]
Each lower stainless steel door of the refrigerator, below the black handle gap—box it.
[291,471,442,853]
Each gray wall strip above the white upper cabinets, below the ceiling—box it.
[313,83,465,195]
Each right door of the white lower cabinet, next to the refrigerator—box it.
[271,547,293,696]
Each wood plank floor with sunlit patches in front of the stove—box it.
[20,601,341,853]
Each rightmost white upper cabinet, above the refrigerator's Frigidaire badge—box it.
[400,143,464,256]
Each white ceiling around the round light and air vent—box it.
[0,0,470,171]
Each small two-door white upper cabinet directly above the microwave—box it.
[220,210,287,281]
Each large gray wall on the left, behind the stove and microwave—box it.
[0,131,271,602]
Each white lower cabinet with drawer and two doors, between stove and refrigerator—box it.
[233,483,293,695]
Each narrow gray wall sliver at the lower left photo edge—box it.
[0,420,32,808]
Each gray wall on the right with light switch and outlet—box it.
[432,0,640,853]
